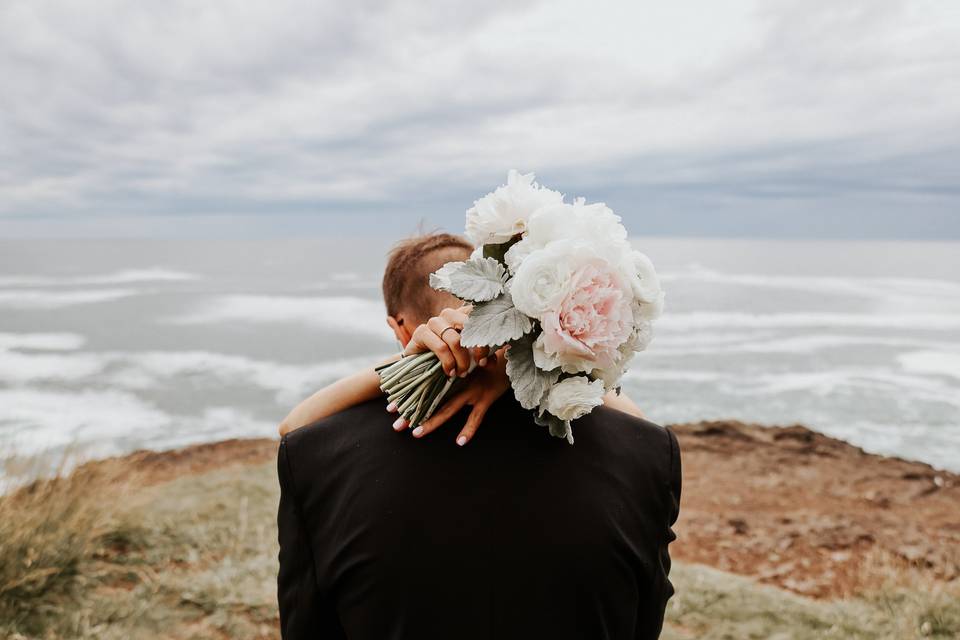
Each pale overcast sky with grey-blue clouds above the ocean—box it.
[0,0,960,239]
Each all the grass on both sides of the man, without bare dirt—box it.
[0,462,960,640]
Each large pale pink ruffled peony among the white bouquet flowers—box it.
[538,258,633,371]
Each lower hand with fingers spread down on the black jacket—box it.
[413,350,510,447]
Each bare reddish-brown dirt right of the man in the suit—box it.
[672,421,960,597]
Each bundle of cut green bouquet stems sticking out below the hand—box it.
[377,351,461,427]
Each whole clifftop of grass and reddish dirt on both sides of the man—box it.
[0,421,960,640]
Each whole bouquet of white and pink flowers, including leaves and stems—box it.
[379,171,663,443]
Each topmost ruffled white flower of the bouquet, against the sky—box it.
[466,170,563,246]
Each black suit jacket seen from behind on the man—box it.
[278,393,680,640]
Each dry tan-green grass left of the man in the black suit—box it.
[0,464,278,640]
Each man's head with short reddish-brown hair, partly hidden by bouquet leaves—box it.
[383,233,473,344]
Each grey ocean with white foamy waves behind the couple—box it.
[0,237,960,475]
